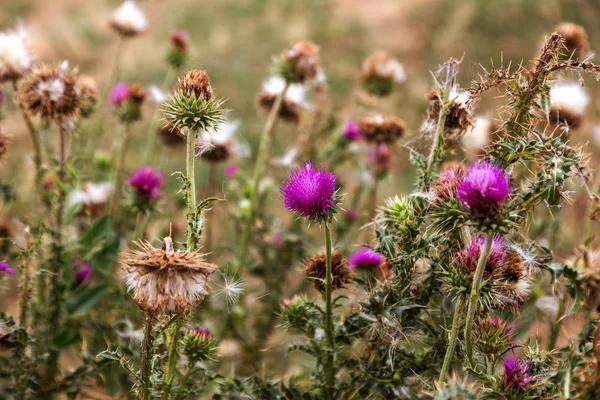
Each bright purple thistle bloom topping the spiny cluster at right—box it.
[457,160,511,213]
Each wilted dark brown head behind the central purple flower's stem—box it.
[304,250,352,293]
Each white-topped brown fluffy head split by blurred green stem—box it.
[256,76,310,125]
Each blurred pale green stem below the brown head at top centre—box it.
[237,83,289,276]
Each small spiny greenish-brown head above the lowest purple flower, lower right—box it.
[473,316,514,356]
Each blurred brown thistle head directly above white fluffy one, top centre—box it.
[275,40,322,83]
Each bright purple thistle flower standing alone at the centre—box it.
[280,161,338,221]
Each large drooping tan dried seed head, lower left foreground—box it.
[120,237,218,315]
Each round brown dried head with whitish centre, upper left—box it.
[19,63,82,121]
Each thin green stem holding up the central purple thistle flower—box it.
[325,222,335,399]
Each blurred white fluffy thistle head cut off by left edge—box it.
[0,28,33,84]
